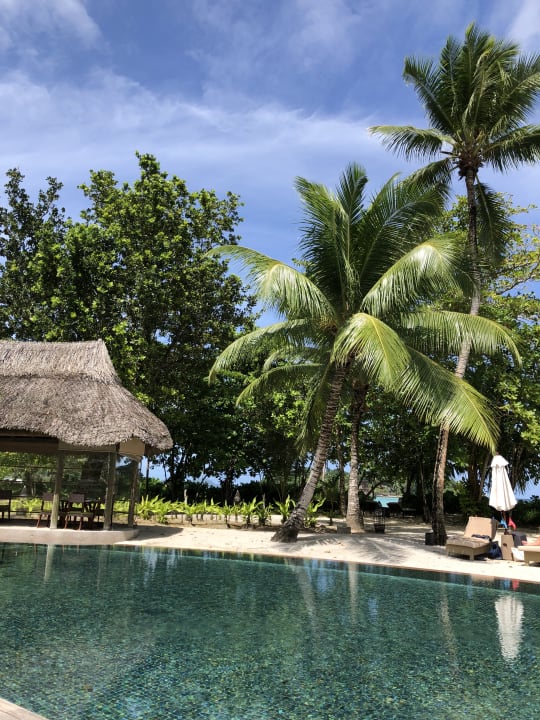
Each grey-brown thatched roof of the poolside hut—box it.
[0,340,172,455]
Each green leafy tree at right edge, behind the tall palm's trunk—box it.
[426,195,540,510]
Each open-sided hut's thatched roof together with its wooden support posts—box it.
[0,340,172,529]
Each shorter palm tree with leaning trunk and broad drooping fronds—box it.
[210,164,515,542]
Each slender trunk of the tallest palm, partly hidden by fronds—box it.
[431,168,481,545]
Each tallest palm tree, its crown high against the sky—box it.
[370,24,540,544]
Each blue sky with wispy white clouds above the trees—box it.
[0,0,540,268]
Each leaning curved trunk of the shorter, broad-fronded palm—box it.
[272,366,347,542]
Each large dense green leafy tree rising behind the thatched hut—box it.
[0,155,253,495]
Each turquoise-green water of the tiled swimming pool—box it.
[0,545,540,720]
